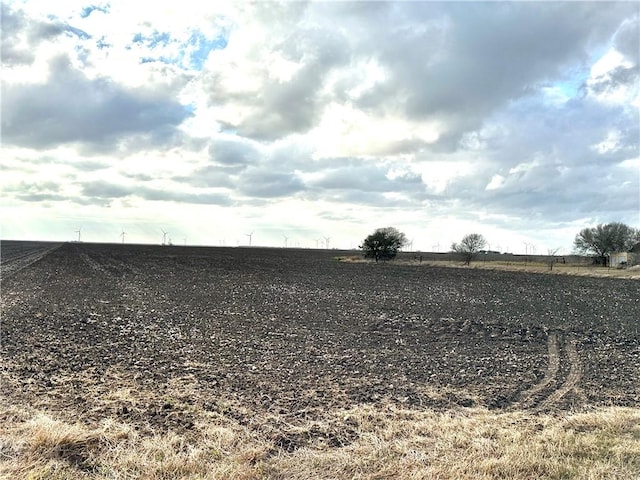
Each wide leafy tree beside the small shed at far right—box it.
[573,222,640,266]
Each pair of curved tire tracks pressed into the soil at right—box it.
[511,332,582,411]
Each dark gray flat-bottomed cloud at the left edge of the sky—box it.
[2,57,188,148]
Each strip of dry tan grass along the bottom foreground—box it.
[0,405,640,480]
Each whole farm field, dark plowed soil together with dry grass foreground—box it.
[0,242,640,478]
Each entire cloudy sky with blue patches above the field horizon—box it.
[0,0,640,253]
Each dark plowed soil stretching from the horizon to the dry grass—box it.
[0,243,640,434]
